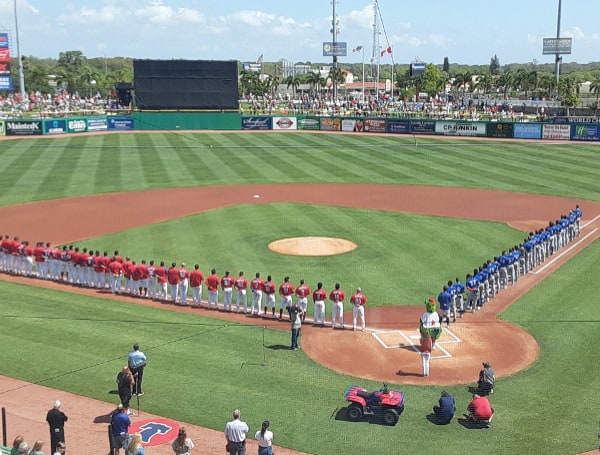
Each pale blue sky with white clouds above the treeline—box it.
[0,0,600,65]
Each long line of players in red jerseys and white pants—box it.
[0,240,367,330]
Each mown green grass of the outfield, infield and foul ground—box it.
[0,133,600,454]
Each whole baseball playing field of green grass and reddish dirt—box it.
[0,132,600,454]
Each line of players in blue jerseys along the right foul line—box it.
[438,205,582,327]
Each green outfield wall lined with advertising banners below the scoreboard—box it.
[0,111,600,142]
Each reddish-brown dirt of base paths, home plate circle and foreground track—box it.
[0,184,600,455]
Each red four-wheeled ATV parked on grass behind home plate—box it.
[344,384,404,425]
